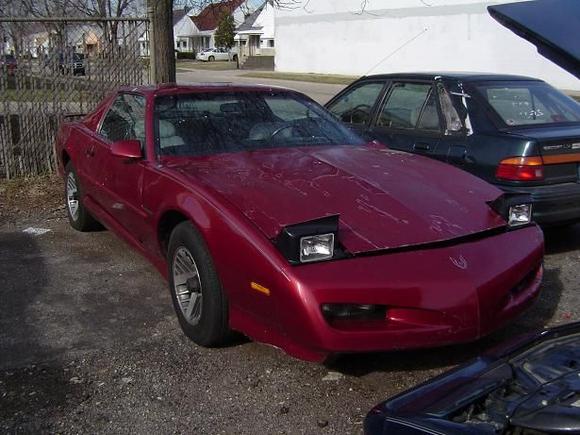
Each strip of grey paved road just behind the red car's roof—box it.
[177,69,345,104]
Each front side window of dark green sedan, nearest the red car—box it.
[328,82,384,124]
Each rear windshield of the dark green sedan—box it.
[476,81,580,126]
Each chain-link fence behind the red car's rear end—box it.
[0,18,149,178]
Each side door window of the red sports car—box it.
[100,94,145,145]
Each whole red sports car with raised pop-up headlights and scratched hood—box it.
[57,85,543,361]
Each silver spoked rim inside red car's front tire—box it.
[172,246,203,326]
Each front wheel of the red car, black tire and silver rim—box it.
[167,222,230,347]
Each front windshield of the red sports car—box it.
[155,91,364,156]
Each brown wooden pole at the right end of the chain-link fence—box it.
[147,0,175,84]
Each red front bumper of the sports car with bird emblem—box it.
[278,226,543,360]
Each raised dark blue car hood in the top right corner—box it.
[487,0,580,78]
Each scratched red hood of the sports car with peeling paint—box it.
[168,146,505,253]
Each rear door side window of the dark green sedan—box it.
[377,83,440,131]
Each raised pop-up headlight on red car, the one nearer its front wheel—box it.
[274,215,344,264]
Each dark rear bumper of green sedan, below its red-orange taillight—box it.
[497,183,580,225]
